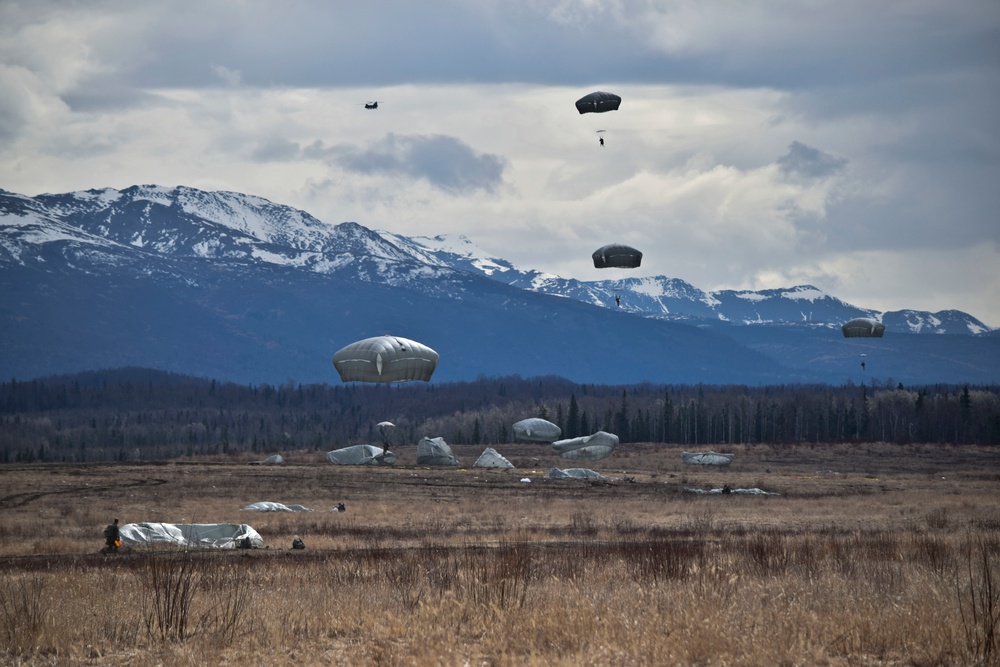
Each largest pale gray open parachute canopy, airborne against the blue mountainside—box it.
[333,336,440,382]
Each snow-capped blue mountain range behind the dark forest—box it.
[0,186,1000,384]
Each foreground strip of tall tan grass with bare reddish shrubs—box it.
[0,529,1000,665]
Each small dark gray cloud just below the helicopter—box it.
[322,134,506,195]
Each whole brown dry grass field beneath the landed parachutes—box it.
[0,444,1000,666]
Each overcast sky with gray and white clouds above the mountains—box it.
[0,0,1000,327]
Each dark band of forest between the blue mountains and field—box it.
[0,369,1000,462]
